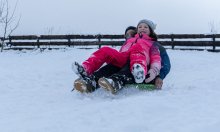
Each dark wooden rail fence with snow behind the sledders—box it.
[1,34,220,51]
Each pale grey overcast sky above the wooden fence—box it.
[2,0,220,35]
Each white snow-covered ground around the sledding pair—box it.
[0,48,220,132]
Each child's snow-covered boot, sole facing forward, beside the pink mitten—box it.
[132,64,145,83]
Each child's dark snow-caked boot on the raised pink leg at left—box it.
[72,61,87,78]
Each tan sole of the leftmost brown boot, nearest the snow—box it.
[73,79,90,93]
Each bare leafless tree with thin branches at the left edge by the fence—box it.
[0,0,21,52]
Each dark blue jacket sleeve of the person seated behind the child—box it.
[156,43,171,80]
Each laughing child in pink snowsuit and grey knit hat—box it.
[72,20,161,83]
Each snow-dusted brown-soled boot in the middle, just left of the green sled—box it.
[98,78,121,94]
